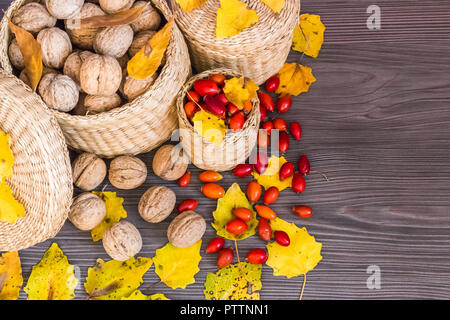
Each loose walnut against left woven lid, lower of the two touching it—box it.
[69,192,106,231]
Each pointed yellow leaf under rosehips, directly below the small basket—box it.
[211,183,258,240]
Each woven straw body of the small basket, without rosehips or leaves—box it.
[177,69,260,171]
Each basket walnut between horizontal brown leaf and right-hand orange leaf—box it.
[94,24,134,58]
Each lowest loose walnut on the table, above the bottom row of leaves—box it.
[102,220,142,261]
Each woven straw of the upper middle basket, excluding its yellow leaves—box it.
[170,0,300,84]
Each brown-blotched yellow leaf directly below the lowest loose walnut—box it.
[84,257,153,300]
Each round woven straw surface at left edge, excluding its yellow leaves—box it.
[0,70,73,251]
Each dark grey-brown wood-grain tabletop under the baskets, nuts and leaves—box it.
[0,0,450,300]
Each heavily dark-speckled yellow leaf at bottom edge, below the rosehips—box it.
[203,262,262,300]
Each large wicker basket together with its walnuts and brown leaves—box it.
[0,0,190,158]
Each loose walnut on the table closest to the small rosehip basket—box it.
[152,144,188,181]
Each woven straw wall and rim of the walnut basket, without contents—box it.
[0,0,191,158]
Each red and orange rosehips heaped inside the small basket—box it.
[184,74,252,131]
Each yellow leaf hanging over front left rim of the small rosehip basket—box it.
[192,110,227,147]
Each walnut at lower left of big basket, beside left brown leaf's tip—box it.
[38,73,80,112]
